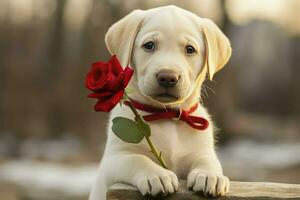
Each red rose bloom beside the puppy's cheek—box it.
[85,55,133,112]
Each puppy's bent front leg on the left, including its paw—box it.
[104,153,178,196]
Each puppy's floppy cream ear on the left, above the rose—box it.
[105,10,145,66]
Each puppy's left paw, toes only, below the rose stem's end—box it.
[137,169,178,196]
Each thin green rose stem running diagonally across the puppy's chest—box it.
[125,93,168,169]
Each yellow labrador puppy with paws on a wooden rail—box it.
[90,6,231,200]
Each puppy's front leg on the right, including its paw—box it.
[188,156,229,197]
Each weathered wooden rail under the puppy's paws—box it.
[107,180,300,200]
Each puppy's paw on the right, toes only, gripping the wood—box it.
[187,169,229,197]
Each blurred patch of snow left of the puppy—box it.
[0,160,98,195]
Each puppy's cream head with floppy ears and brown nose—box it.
[105,6,231,105]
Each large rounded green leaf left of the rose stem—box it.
[112,117,144,144]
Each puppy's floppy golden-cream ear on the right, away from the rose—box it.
[201,18,231,80]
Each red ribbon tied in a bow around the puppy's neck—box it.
[124,99,208,130]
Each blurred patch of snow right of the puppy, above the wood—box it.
[219,140,300,169]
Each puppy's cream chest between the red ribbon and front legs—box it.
[151,120,213,169]
